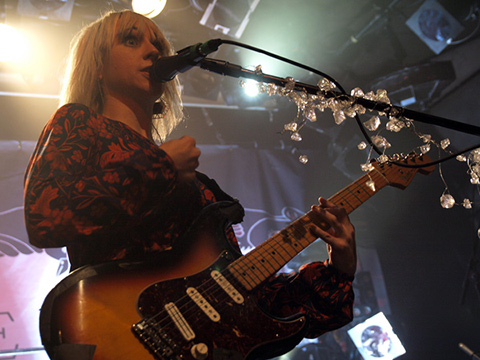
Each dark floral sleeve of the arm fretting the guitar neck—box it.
[256,261,354,338]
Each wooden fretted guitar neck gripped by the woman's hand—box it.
[229,168,389,290]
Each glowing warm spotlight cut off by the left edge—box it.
[0,24,30,62]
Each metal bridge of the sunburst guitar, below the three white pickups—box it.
[132,319,182,360]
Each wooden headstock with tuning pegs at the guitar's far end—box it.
[371,154,435,189]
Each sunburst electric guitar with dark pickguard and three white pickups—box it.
[40,155,433,360]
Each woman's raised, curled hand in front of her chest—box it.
[160,136,200,181]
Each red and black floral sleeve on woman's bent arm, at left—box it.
[24,104,176,247]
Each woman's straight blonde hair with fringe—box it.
[60,10,183,140]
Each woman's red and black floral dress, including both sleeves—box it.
[25,104,353,337]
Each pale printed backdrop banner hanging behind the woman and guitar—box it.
[0,141,389,360]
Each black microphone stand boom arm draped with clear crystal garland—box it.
[198,58,480,136]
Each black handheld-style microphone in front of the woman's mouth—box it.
[150,39,222,82]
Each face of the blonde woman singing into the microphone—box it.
[101,23,164,103]
